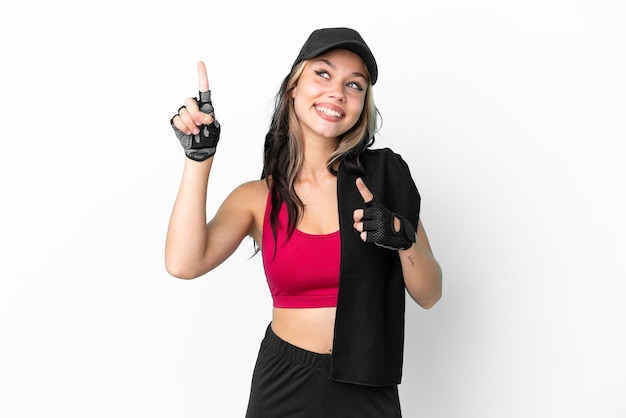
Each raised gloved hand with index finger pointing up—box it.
[170,61,221,161]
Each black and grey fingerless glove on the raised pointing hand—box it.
[170,91,221,161]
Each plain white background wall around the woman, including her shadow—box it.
[0,0,626,418]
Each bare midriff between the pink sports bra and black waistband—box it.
[272,308,337,354]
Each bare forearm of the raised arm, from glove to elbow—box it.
[165,158,213,279]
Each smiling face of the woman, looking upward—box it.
[292,49,369,139]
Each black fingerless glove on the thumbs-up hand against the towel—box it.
[363,199,415,250]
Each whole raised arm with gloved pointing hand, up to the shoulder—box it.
[165,62,258,279]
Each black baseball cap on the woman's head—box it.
[293,28,378,85]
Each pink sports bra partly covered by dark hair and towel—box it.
[261,194,341,308]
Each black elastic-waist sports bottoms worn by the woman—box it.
[246,326,402,418]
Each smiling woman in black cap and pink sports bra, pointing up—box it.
[166,28,441,418]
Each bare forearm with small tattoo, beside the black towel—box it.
[399,238,442,309]
